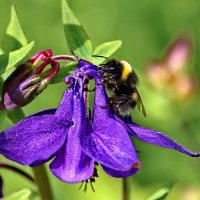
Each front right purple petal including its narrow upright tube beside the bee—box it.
[81,82,138,171]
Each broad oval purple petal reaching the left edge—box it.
[0,115,69,165]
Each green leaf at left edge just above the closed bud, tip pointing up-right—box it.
[0,42,34,78]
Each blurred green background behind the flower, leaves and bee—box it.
[0,0,200,200]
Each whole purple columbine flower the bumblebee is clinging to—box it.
[0,60,199,183]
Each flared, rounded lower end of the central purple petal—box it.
[50,141,94,183]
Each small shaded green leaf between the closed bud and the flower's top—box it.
[51,63,77,84]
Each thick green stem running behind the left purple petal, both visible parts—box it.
[8,109,54,200]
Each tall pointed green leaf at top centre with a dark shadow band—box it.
[62,0,92,59]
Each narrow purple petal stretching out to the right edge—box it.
[127,123,200,157]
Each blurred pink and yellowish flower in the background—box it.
[146,37,196,101]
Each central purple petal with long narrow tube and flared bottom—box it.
[50,96,94,183]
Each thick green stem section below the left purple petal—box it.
[33,165,54,200]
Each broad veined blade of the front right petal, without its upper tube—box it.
[81,125,138,171]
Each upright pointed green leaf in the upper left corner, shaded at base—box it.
[0,6,27,54]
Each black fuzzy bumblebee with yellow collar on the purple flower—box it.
[99,59,146,117]
